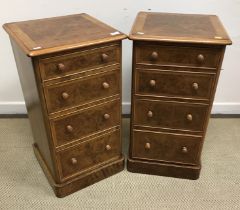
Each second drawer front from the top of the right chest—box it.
[136,69,215,99]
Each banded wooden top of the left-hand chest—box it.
[3,13,126,56]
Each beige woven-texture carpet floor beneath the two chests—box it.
[0,118,240,210]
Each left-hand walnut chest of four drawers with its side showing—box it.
[4,14,126,197]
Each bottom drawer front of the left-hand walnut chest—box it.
[57,130,121,178]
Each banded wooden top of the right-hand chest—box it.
[129,12,231,45]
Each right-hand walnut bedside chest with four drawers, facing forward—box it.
[127,12,231,179]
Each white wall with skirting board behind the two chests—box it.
[0,0,240,114]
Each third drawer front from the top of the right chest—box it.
[134,100,208,131]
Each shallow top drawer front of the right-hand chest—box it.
[136,45,221,68]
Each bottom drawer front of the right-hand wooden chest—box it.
[132,130,202,165]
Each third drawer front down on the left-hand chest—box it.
[51,100,120,146]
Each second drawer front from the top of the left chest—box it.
[44,69,120,113]
